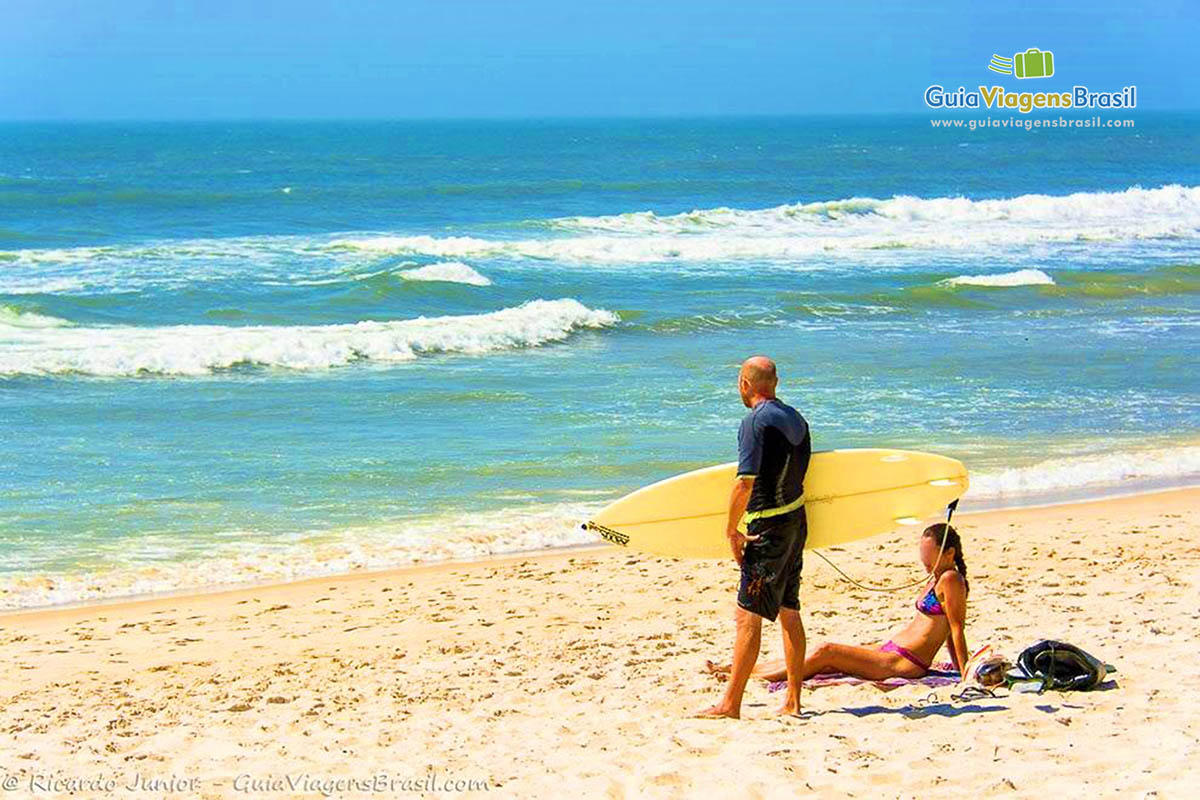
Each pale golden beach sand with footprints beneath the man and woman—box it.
[0,489,1200,798]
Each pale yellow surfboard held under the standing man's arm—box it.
[583,449,970,558]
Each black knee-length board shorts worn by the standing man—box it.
[738,506,809,621]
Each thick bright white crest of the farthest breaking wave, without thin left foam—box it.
[328,186,1200,264]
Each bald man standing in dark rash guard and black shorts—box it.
[700,356,812,720]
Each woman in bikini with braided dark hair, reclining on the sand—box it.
[707,523,967,681]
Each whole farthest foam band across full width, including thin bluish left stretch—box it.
[9,185,1200,283]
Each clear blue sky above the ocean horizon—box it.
[0,0,1200,119]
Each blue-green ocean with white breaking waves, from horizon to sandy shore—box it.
[0,114,1200,607]
